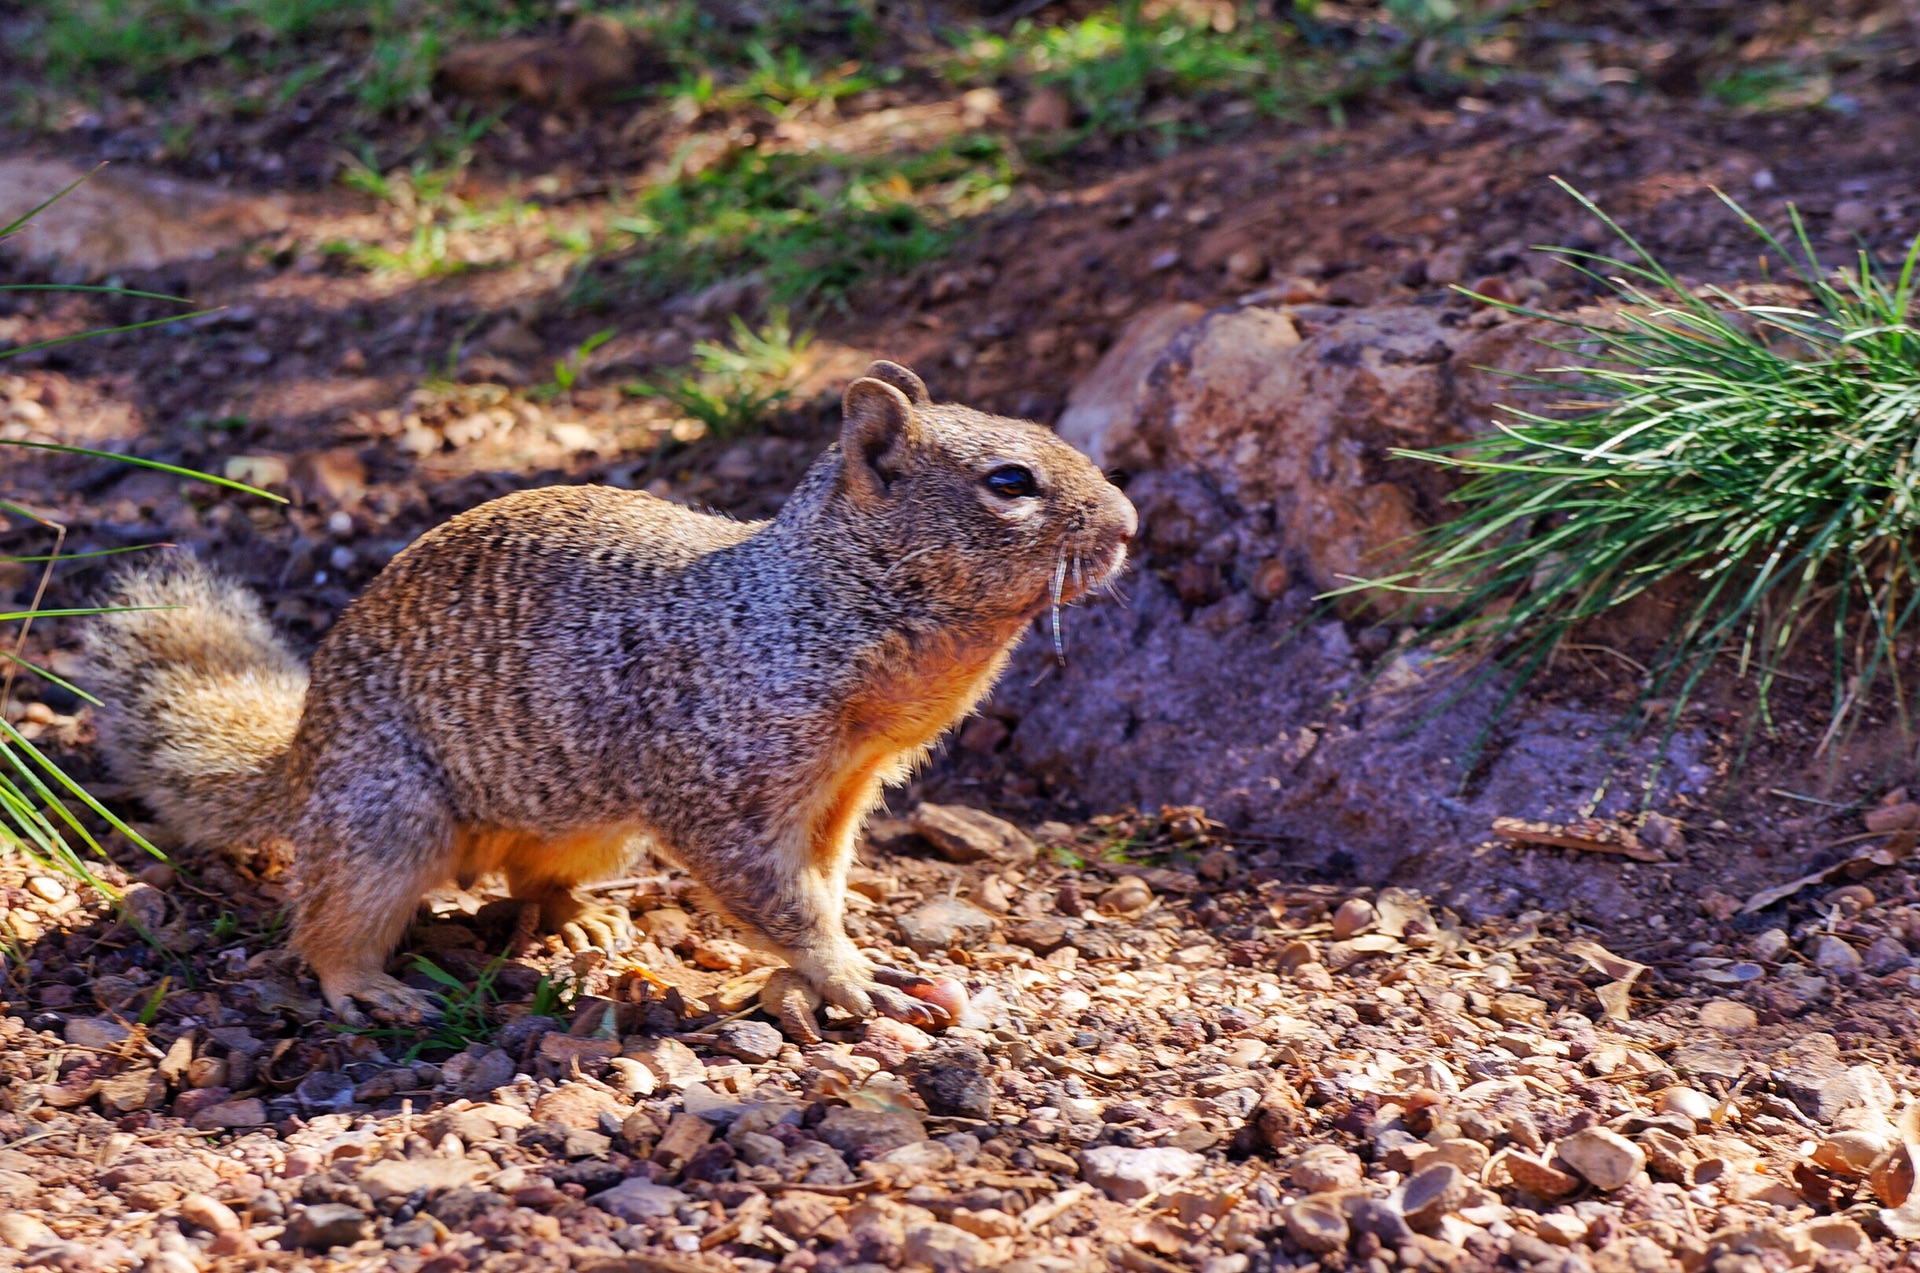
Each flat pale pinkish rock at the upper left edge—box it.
[0,157,288,278]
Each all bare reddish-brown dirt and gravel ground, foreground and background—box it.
[0,6,1920,1273]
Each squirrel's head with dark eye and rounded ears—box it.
[814,363,1139,628]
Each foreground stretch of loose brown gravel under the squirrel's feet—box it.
[0,806,1920,1273]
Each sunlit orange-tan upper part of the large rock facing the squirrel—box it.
[1062,305,1557,588]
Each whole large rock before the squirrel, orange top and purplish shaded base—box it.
[956,305,1713,902]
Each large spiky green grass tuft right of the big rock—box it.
[1344,182,1920,768]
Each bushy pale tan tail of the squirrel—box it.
[86,555,307,849]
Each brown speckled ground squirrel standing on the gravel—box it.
[86,361,1139,1025]
